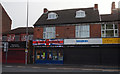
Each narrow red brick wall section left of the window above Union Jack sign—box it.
[34,27,43,39]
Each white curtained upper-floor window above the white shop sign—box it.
[76,25,90,38]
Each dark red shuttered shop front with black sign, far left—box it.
[2,41,25,64]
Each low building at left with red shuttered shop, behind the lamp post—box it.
[2,27,33,63]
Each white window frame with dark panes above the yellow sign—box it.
[101,24,119,37]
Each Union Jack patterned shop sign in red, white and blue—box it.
[33,39,63,45]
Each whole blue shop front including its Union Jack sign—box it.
[33,39,64,64]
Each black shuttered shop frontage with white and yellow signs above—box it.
[64,38,120,66]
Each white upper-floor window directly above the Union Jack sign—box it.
[43,27,56,39]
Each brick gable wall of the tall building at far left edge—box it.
[2,5,12,32]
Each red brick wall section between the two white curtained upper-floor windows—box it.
[56,26,75,38]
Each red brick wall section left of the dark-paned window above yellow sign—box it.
[90,24,101,38]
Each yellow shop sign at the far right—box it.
[102,38,120,44]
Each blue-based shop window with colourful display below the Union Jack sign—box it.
[35,49,63,64]
